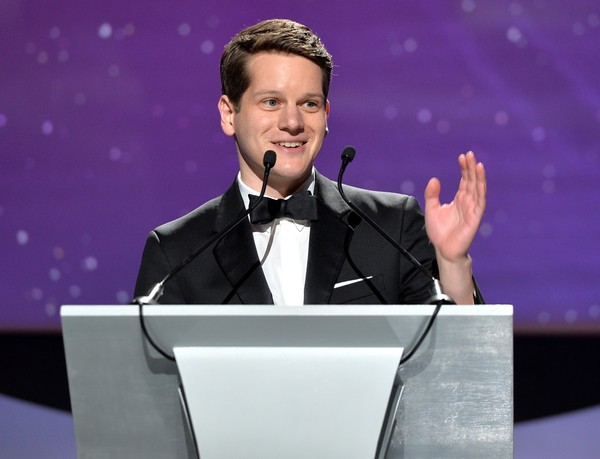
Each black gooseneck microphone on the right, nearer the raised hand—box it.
[337,145,456,305]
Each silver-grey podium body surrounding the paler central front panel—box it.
[61,305,513,459]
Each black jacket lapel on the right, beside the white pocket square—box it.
[304,173,351,304]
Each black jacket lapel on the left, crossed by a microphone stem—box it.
[213,182,273,304]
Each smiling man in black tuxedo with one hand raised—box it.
[135,20,486,305]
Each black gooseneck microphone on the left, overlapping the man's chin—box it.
[131,150,277,306]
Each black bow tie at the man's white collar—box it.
[249,191,317,225]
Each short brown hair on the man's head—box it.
[220,19,333,107]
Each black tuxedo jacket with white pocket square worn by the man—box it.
[135,173,437,304]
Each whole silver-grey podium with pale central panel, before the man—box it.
[61,305,513,459]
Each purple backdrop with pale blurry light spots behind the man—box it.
[0,0,600,329]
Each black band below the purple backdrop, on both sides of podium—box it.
[0,332,600,422]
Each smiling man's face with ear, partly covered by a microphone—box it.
[219,52,329,197]
